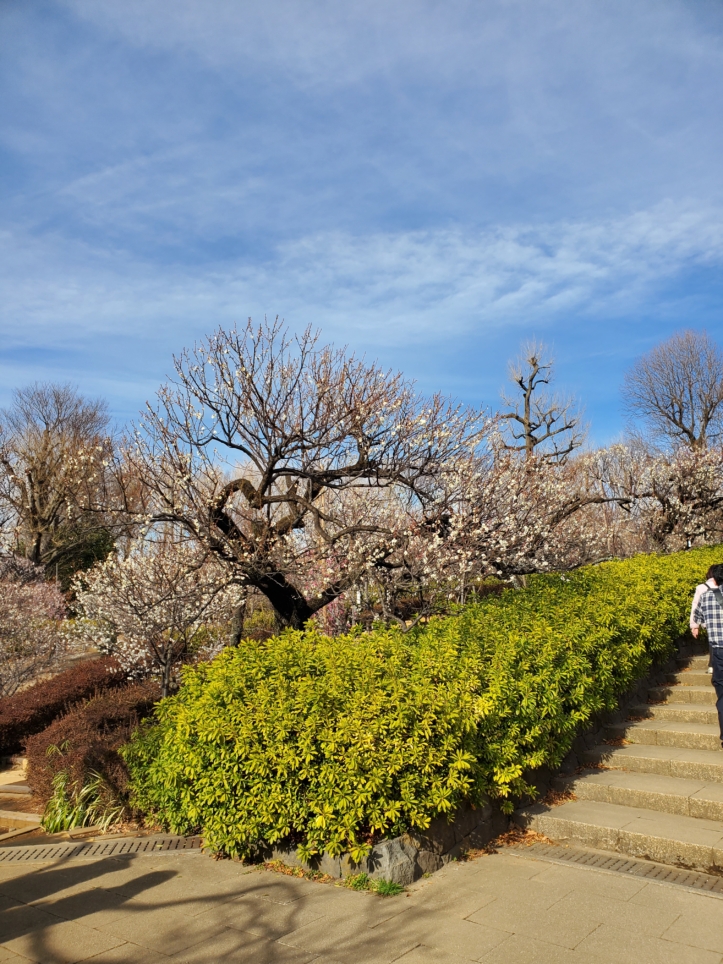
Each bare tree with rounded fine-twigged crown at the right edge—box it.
[623,330,723,449]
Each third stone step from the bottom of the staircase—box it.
[583,743,723,783]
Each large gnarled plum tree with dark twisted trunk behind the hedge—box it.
[128,319,482,627]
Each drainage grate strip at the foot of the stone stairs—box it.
[505,843,723,894]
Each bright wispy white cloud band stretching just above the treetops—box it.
[0,203,723,347]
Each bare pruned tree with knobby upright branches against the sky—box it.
[500,341,586,462]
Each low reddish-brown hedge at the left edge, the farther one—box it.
[0,656,127,754]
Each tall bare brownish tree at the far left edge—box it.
[0,384,124,574]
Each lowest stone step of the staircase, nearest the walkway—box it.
[514,800,723,873]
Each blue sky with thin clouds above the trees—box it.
[0,0,723,443]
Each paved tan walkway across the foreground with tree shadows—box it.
[0,851,723,964]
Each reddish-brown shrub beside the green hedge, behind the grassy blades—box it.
[27,680,160,803]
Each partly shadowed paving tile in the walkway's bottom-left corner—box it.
[0,906,122,964]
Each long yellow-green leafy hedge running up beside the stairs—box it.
[122,549,721,860]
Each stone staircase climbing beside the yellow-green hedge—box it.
[515,655,723,874]
